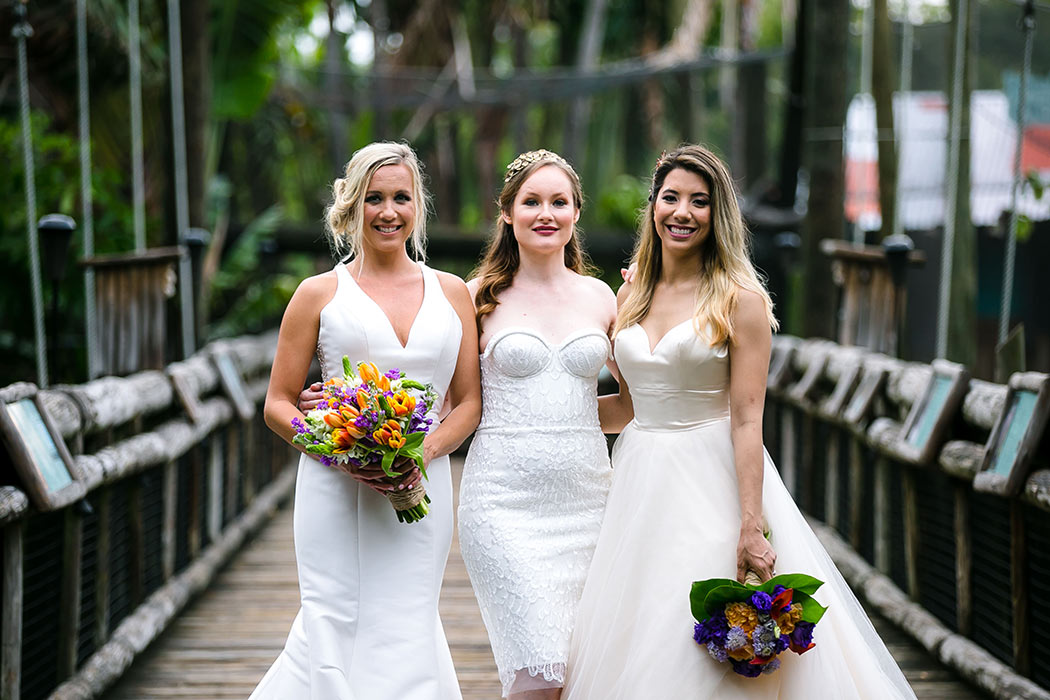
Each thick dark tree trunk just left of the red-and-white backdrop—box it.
[795,0,849,338]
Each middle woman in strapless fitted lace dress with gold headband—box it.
[459,150,616,700]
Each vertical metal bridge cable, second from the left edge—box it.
[77,0,100,379]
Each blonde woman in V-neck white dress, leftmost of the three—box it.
[251,143,481,700]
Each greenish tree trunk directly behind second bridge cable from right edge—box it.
[945,0,978,367]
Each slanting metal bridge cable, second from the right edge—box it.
[937,0,969,358]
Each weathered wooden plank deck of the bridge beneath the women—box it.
[105,460,983,700]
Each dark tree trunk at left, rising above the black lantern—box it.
[180,0,211,227]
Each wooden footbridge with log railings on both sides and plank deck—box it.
[0,334,1050,700]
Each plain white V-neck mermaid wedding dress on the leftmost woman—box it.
[251,263,463,700]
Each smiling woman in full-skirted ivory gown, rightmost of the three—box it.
[564,145,915,700]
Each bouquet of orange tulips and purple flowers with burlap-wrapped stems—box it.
[292,356,437,523]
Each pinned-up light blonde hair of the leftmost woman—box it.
[324,142,431,261]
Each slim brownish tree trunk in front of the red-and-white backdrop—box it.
[872,0,897,243]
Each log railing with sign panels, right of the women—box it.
[764,336,1050,698]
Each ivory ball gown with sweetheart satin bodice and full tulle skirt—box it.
[563,321,915,700]
